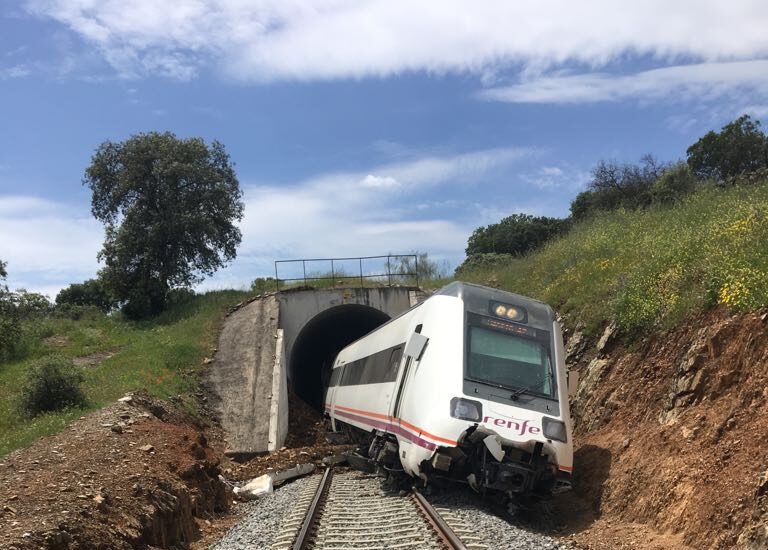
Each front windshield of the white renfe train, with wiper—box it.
[467,325,552,395]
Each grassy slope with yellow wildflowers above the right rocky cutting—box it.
[460,182,768,333]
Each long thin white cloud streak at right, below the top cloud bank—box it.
[479,59,768,103]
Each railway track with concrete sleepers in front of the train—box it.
[271,469,487,550]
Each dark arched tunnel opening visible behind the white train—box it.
[288,304,389,410]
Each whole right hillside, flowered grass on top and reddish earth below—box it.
[458,182,768,549]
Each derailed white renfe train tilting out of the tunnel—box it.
[325,282,575,508]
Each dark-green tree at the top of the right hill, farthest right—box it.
[688,115,768,182]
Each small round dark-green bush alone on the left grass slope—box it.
[21,355,86,416]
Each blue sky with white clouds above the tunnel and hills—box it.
[0,0,768,297]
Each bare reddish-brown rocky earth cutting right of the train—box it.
[568,311,768,550]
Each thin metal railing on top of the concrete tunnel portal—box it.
[275,254,419,291]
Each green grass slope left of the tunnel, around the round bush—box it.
[0,291,248,456]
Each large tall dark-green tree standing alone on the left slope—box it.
[83,132,243,318]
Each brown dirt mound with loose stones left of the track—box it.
[0,395,231,550]
